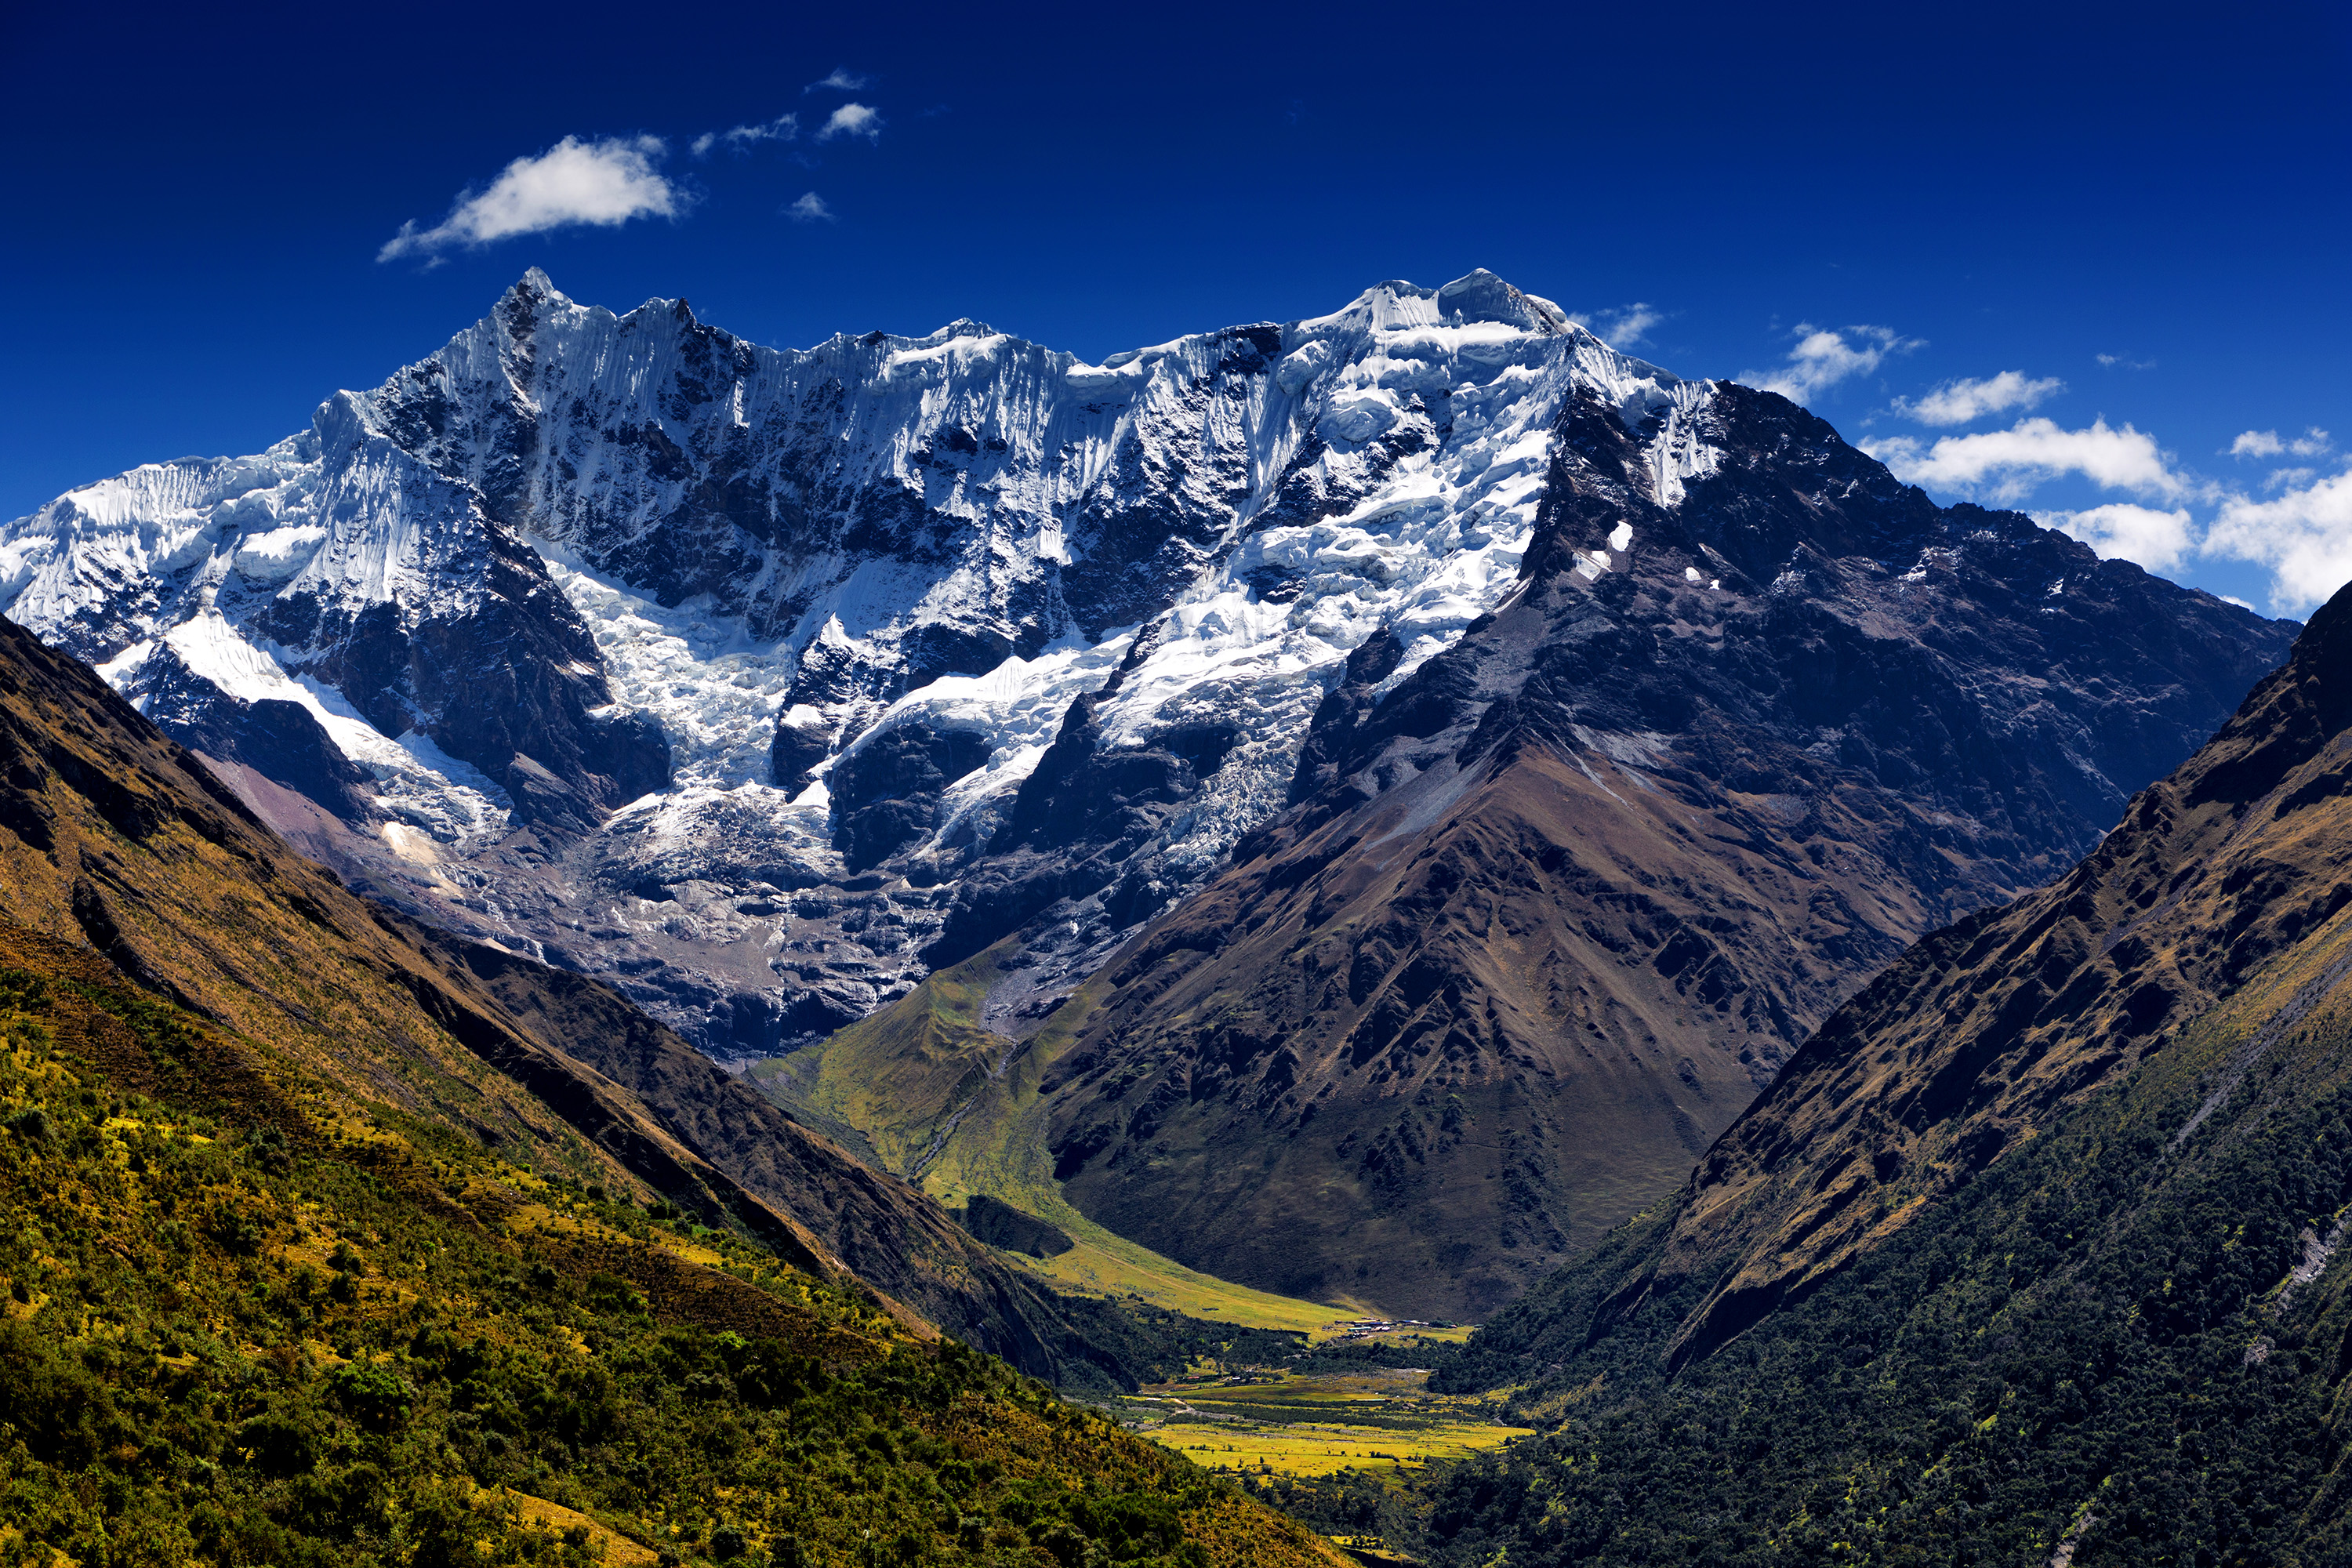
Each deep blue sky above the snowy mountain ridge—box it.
[13,0,2352,609]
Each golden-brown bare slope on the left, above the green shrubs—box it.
[0,626,1148,1377]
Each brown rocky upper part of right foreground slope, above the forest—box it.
[1621,573,2352,1356]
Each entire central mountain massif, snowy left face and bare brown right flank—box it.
[0,270,2293,1316]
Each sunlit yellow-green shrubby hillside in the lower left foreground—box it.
[0,928,1329,1568]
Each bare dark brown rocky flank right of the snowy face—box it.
[1035,373,2291,1316]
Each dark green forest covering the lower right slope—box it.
[1374,916,2352,1568]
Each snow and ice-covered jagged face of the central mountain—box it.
[0,270,1722,1053]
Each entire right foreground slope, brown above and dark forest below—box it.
[1402,580,2352,1566]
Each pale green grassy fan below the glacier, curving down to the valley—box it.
[753,940,1355,1333]
